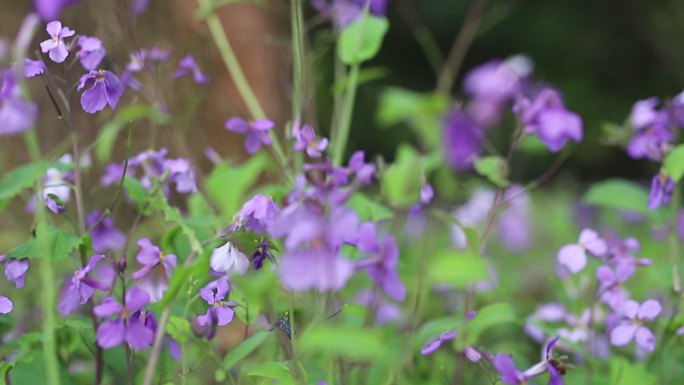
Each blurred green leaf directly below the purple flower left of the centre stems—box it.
[205,153,269,220]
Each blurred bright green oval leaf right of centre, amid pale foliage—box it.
[428,250,489,289]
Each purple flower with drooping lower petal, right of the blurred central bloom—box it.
[356,222,406,301]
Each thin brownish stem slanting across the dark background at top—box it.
[437,0,488,94]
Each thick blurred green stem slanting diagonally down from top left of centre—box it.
[197,0,288,176]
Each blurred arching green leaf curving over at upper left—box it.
[95,104,169,163]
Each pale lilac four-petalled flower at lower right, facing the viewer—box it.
[610,299,662,352]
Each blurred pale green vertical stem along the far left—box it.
[24,130,60,385]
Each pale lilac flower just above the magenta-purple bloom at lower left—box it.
[131,238,177,302]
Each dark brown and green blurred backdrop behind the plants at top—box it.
[0,0,684,181]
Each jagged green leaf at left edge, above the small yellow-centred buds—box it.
[7,225,83,261]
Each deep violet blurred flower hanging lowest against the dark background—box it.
[442,108,484,171]
